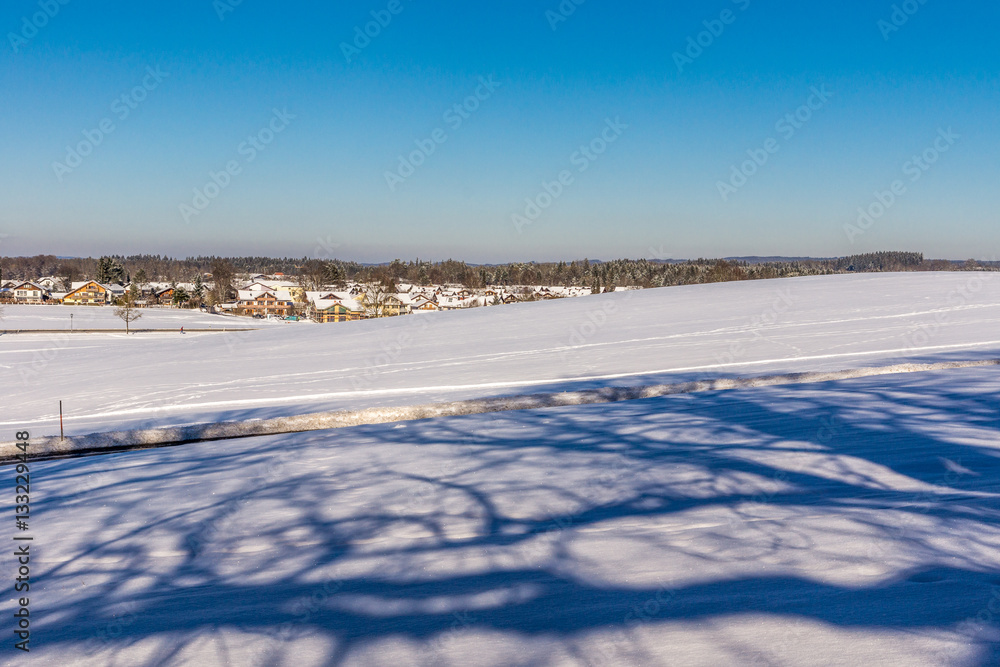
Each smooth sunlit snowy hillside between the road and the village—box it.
[0,273,1000,435]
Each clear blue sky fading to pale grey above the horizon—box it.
[0,0,1000,262]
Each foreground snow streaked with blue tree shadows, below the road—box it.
[17,367,1000,667]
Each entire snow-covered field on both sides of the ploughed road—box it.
[0,273,1000,667]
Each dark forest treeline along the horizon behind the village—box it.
[0,252,1000,291]
